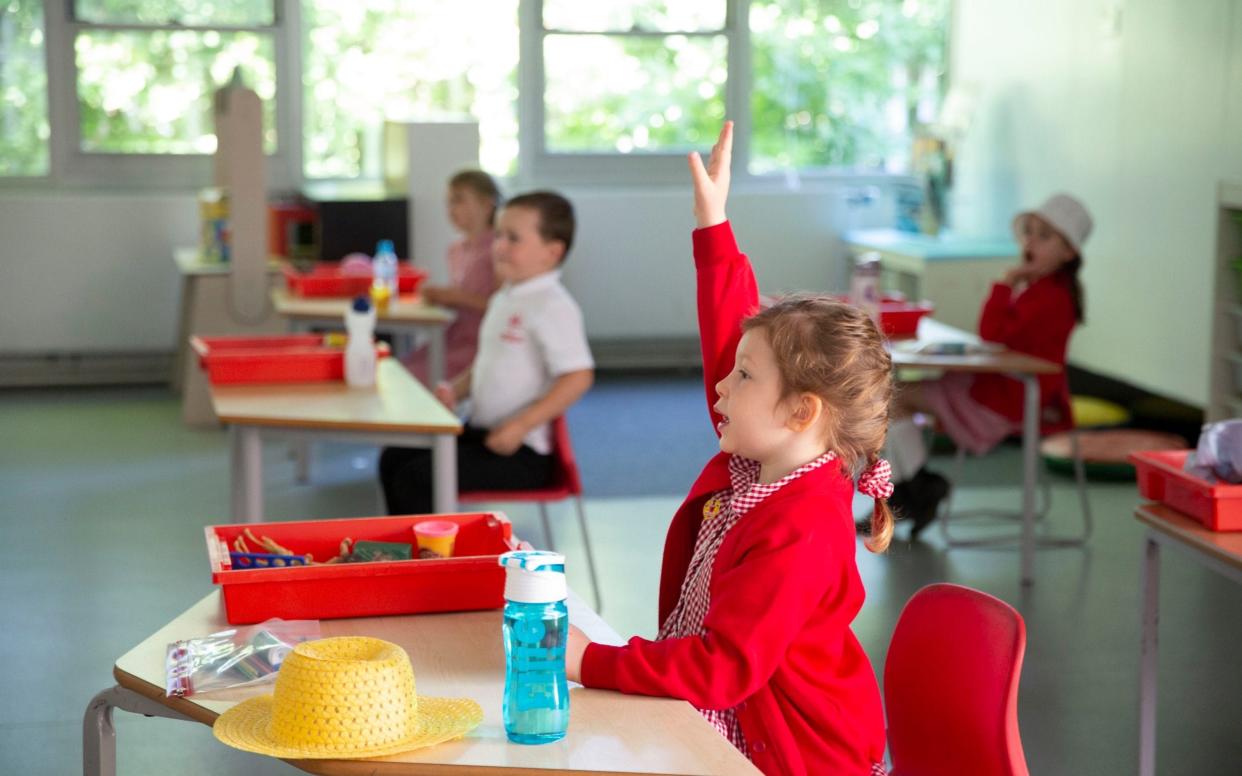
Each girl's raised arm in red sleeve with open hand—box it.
[689,122,759,428]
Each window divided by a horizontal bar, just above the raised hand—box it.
[542,0,729,154]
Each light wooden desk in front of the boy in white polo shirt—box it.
[211,359,462,523]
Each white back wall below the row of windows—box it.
[0,184,892,354]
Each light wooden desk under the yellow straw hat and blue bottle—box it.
[83,591,759,776]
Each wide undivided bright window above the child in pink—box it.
[302,0,518,178]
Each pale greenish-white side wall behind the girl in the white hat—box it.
[951,0,1242,406]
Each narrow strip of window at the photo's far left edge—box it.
[0,0,51,176]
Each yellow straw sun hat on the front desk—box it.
[212,636,483,759]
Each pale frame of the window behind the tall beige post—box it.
[38,0,302,189]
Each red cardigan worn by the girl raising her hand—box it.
[582,223,884,775]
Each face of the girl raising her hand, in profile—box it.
[714,329,792,463]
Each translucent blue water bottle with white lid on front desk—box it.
[501,550,569,744]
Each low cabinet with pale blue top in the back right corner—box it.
[845,228,1021,329]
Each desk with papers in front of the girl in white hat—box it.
[892,318,1061,585]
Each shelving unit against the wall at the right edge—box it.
[1207,180,1242,422]
